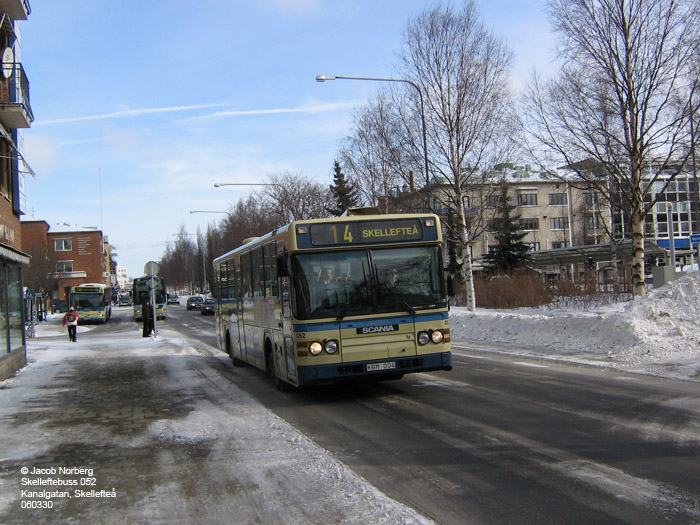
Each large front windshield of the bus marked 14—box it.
[292,246,447,320]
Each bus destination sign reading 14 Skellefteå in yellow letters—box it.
[310,219,423,246]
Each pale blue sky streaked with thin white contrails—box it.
[21,0,553,277]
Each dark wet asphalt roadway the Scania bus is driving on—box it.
[168,307,700,524]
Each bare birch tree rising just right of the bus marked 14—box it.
[400,0,514,311]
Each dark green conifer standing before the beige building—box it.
[483,184,530,273]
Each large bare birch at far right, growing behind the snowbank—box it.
[524,0,700,295]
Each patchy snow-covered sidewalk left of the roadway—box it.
[0,310,430,524]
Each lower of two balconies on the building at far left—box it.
[0,61,34,129]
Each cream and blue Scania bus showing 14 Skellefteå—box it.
[214,208,452,389]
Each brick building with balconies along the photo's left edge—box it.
[0,0,34,380]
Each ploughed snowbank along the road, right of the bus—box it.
[450,272,700,381]
